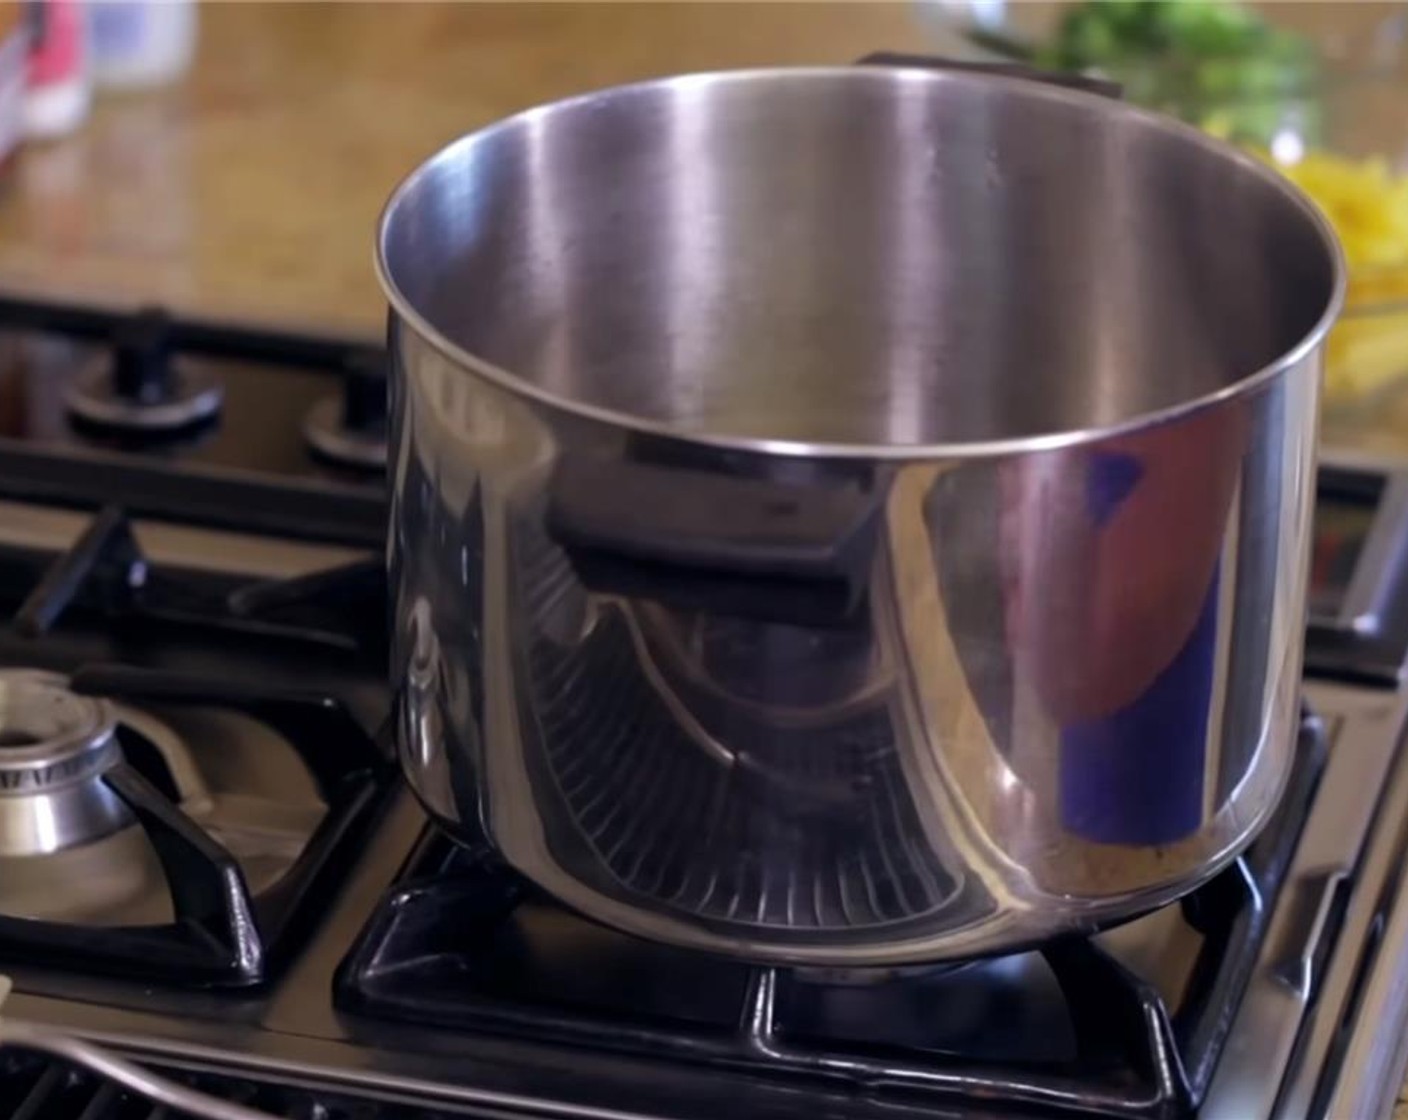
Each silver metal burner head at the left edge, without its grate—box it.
[0,669,132,855]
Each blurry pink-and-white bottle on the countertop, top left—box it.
[24,0,93,139]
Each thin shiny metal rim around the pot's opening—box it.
[373,66,1349,462]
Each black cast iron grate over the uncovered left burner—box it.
[0,507,390,985]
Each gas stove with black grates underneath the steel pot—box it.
[0,299,1408,1120]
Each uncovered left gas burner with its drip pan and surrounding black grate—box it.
[0,666,384,986]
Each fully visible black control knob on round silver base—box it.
[66,310,225,437]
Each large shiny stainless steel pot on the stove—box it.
[377,68,1343,966]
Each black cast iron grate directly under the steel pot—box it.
[337,717,1325,1120]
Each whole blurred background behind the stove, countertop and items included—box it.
[0,0,1408,449]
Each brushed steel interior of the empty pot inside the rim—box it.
[380,68,1338,445]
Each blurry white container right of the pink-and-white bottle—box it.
[89,0,197,89]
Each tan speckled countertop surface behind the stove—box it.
[8,3,1408,1120]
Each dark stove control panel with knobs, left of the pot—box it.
[0,293,386,547]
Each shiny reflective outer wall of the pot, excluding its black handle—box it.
[394,342,1315,961]
